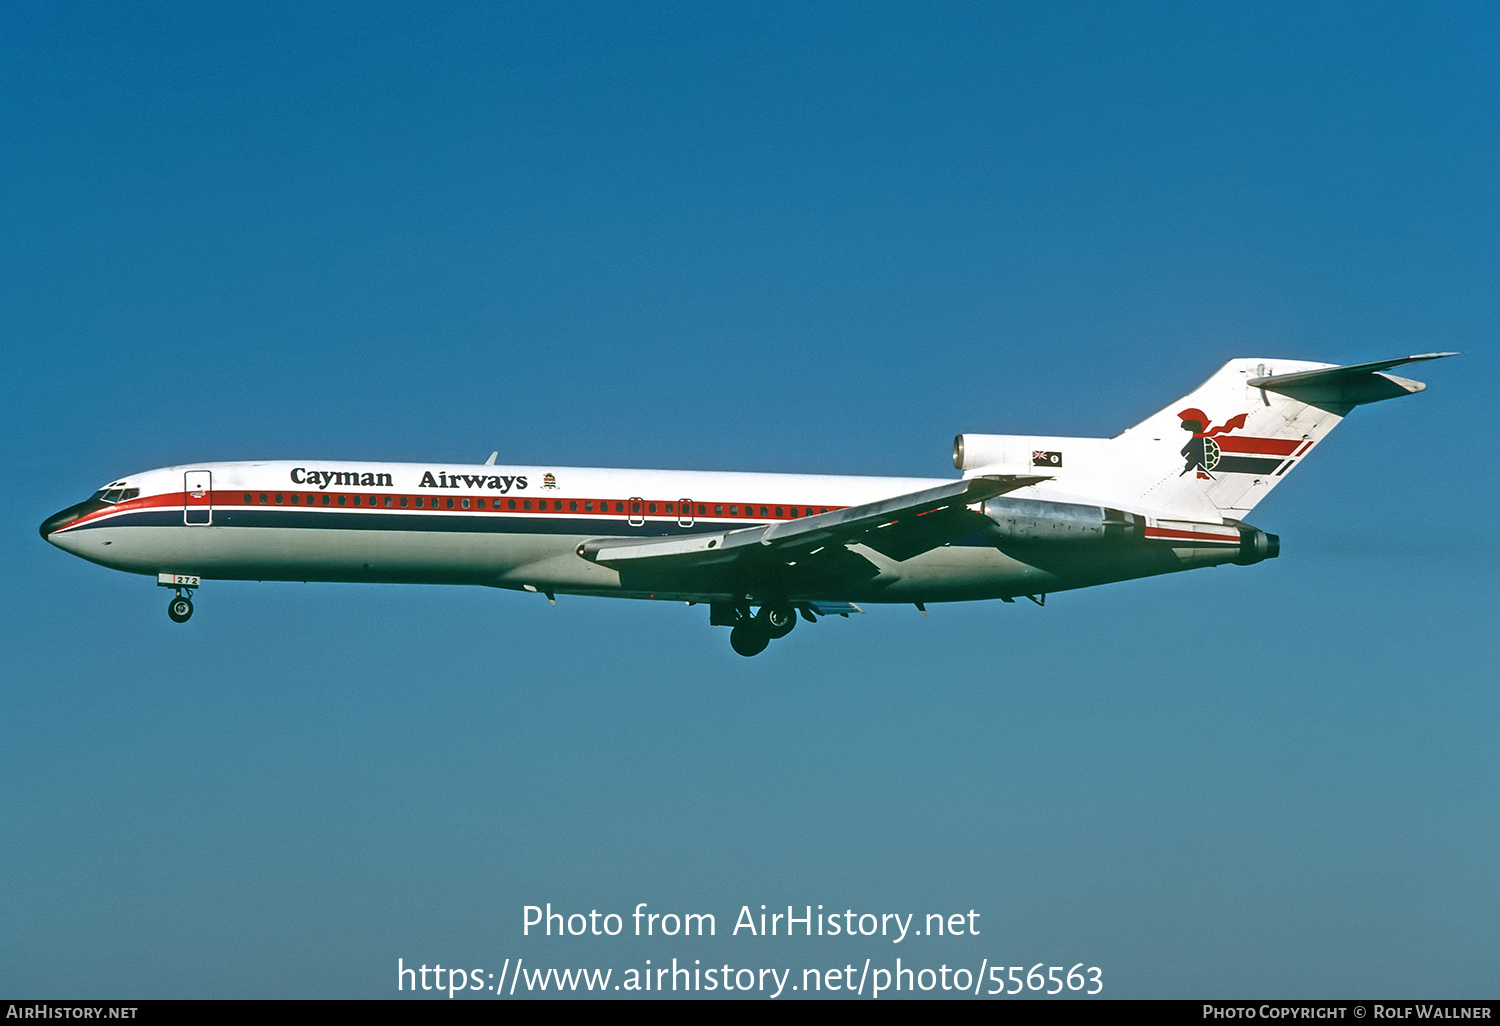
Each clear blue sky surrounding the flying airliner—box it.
[0,3,1500,998]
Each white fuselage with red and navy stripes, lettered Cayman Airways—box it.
[44,461,1233,602]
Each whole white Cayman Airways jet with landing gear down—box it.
[41,353,1458,656]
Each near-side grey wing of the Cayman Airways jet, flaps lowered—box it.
[579,476,1046,578]
